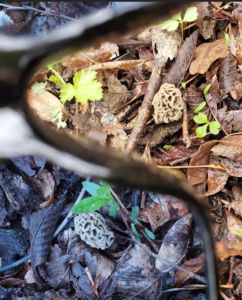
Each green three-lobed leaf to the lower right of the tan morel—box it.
[193,113,220,138]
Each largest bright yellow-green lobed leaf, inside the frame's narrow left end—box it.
[73,70,103,104]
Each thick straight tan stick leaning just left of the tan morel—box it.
[125,66,161,153]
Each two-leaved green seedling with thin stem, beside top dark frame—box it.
[162,7,198,40]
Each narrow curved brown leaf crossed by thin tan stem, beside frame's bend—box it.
[187,141,218,185]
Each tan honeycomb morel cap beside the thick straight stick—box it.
[152,83,184,124]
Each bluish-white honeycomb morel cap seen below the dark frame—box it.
[74,212,114,250]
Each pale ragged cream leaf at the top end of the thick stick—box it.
[152,27,182,69]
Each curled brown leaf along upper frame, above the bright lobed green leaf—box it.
[62,42,119,73]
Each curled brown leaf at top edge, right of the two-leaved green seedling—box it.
[196,2,216,40]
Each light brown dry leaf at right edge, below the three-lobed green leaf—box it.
[211,135,242,163]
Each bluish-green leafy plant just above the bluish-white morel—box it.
[72,181,119,216]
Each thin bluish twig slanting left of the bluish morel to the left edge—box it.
[0,176,91,272]
